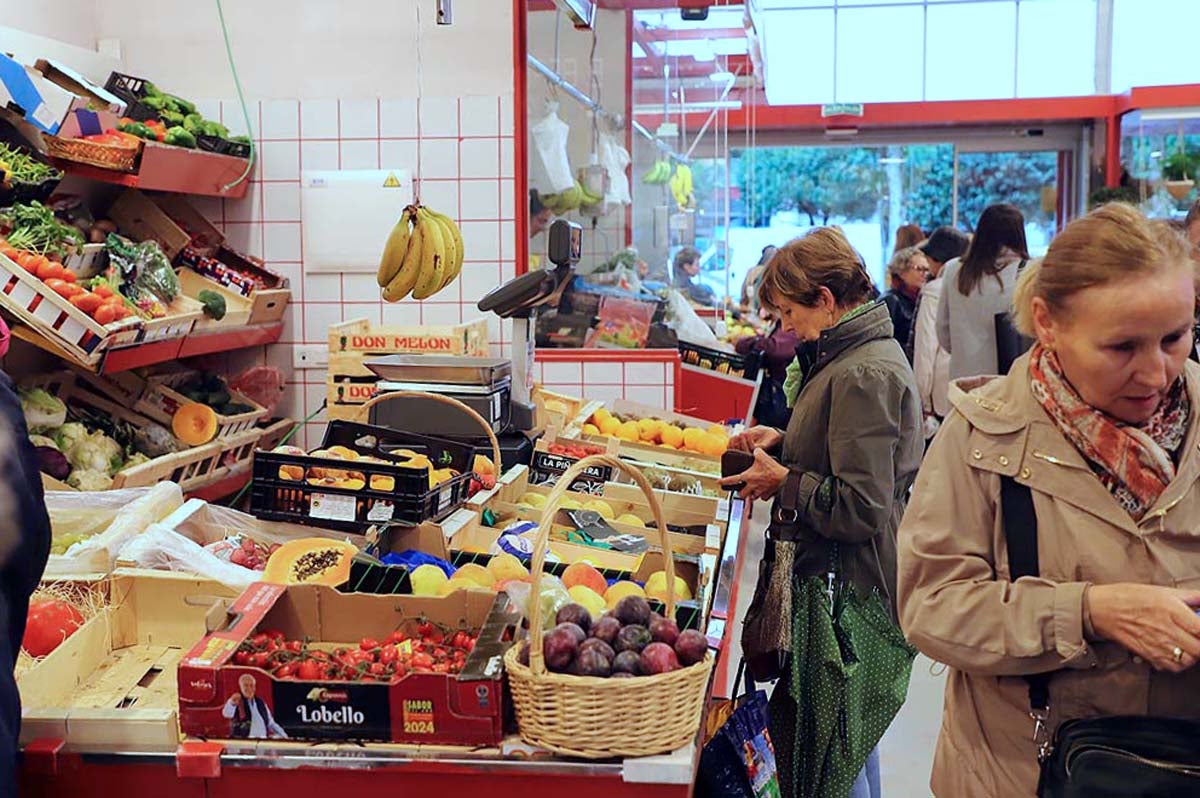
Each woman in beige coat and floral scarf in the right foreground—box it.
[898,205,1200,798]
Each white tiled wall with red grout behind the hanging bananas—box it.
[196,95,516,445]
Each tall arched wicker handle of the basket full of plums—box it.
[528,455,674,676]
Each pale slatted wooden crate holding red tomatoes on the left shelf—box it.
[0,254,143,365]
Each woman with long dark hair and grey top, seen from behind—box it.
[937,204,1030,379]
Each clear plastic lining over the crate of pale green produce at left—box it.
[46,482,184,576]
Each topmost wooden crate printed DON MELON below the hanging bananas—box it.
[329,319,490,362]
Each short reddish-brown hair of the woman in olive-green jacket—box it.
[758,227,871,311]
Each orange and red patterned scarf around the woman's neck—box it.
[1030,344,1190,520]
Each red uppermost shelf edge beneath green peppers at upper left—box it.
[50,142,250,199]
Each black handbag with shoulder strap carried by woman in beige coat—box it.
[1000,476,1200,798]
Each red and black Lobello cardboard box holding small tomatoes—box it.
[179,582,517,745]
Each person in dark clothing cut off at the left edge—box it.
[0,372,50,798]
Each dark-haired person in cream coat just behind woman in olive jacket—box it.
[912,226,970,439]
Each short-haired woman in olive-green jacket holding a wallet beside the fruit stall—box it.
[722,228,923,798]
